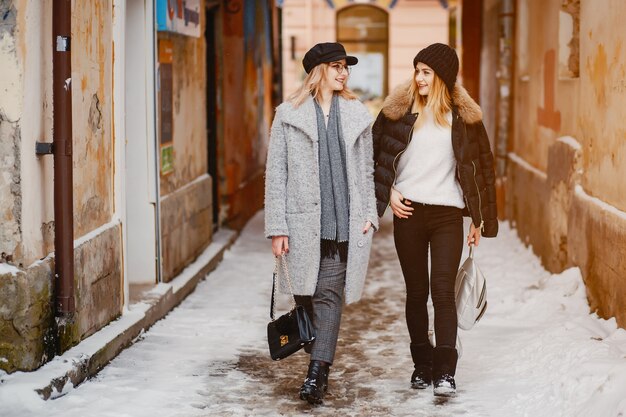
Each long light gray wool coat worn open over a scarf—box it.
[265,98,378,303]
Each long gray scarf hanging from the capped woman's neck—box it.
[315,94,349,249]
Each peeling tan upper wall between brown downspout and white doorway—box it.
[72,0,114,234]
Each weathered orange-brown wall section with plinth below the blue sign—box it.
[158,8,213,282]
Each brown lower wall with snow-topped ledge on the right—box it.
[506,137,626,327]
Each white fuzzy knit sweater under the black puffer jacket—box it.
[394,111,465,208]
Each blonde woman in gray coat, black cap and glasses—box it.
[265,43,378,404]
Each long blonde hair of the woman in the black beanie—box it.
[409,71,452,129]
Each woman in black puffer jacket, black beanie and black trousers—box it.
[372,44,498,396]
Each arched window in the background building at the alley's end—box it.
[336,5,389,99]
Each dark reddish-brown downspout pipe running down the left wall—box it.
[52,0,76,317]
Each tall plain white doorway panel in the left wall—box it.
[124,0,160,302]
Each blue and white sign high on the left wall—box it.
[156,0,201,38]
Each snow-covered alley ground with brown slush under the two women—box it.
[0,213,626,417]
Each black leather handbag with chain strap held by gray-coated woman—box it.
[267,256,315,361]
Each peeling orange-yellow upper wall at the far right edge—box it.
[576,0,626,211]
